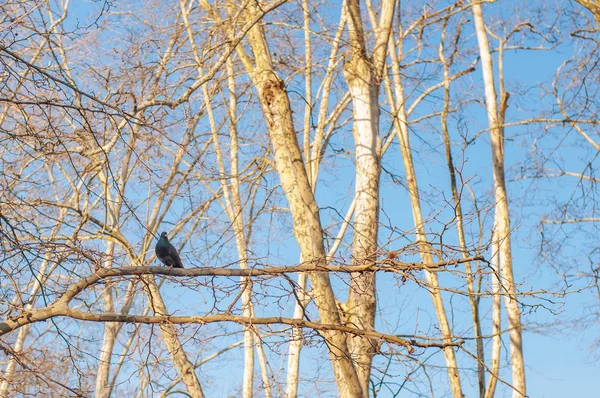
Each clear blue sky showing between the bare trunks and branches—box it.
[3,1,600,397]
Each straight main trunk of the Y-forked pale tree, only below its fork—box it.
[344,53,381,396]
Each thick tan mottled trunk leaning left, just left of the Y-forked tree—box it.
[238,2,363,397]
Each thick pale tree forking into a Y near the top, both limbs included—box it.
[344,0,395,397]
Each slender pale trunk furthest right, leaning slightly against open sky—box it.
[472,3,526,398]
